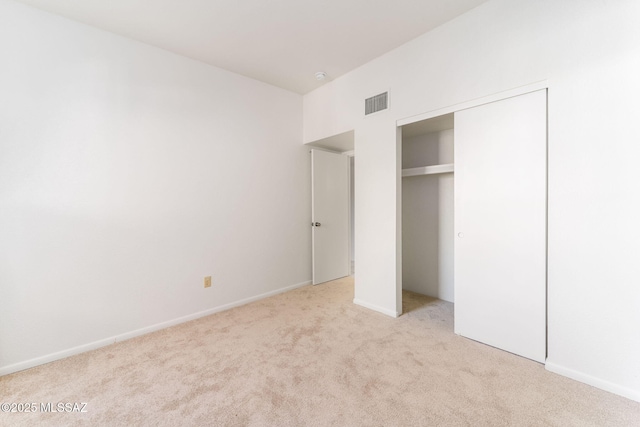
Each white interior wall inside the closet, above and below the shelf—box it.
[402,129,454,302]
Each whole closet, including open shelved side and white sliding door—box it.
[398,88,547,363]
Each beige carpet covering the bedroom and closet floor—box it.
[0,279,640,427]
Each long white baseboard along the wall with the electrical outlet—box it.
[0,280,311,376]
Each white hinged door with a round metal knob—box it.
[311,150,349,285]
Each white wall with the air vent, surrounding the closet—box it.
[304,0,640,400]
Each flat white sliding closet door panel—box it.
[454,90,547,362]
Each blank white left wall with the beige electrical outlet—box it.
[0,0,311,374]
